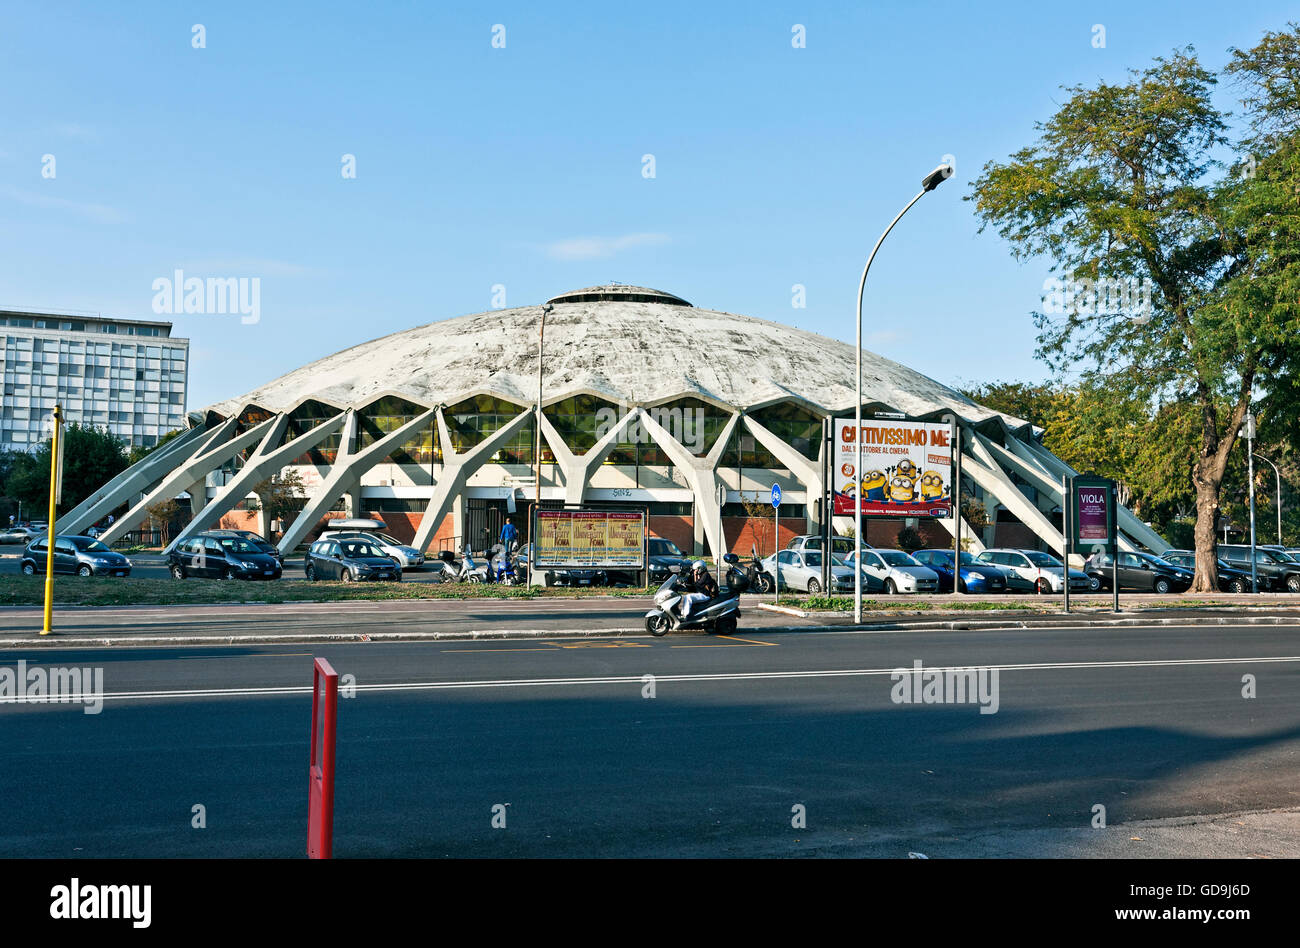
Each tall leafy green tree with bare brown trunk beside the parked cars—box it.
[971,26,1300,592]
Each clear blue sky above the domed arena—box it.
[0,1,1295,410]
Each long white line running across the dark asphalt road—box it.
[15,655,1300,704]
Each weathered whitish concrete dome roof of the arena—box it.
[208,292,1027,429]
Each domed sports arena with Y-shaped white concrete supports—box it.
[59,283,1164,555]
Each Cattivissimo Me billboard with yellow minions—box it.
[835,417,953,518]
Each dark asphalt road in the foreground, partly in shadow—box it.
[0,619,1300,858]
